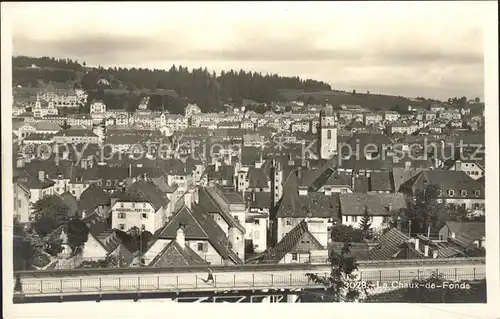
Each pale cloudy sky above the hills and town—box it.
[3,1,488,99]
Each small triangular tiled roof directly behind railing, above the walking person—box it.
[149,240,208,267]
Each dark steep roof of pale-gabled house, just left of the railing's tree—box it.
[261,221,325,263]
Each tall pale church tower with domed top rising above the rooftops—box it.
[319,103,337,159]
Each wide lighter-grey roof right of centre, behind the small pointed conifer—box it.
[339,193,406,216]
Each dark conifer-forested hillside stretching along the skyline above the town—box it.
[13,56,331,113]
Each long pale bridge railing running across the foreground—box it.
[14,267,486,295]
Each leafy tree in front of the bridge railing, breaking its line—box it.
[306,241,370,302]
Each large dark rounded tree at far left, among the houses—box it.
[31,195,69,237]
